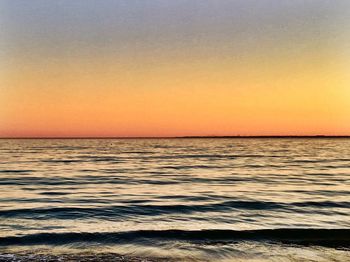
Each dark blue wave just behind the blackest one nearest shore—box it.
[0,201,350,219]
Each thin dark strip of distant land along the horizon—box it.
[0,135,350,139]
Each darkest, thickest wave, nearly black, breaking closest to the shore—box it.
[0,228,350,248]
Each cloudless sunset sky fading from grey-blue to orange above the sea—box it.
[0,0,350,137]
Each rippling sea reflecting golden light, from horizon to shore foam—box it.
[0,139,350,261]
